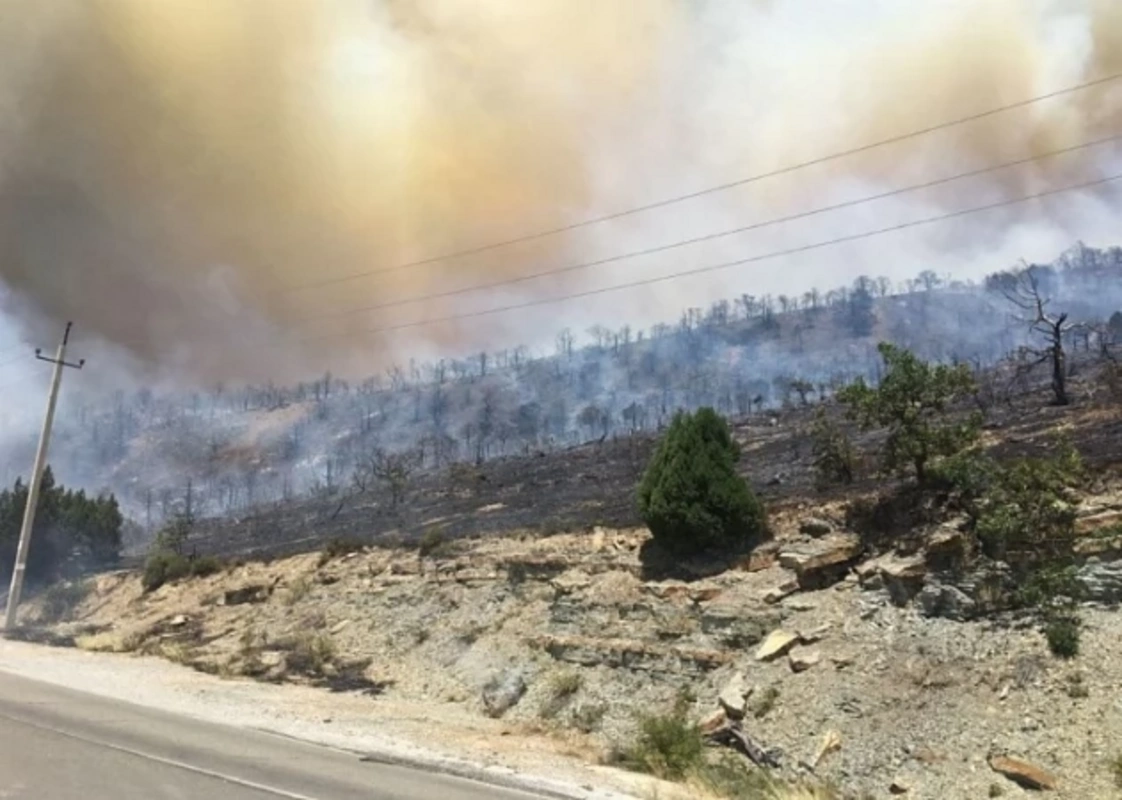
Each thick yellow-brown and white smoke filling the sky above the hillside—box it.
[0,0,1122,380]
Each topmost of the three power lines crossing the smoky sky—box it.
[277,73,1122,294]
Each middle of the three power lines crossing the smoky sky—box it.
[295,134,1122,327]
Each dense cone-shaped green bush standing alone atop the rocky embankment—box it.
[638,408,767,555]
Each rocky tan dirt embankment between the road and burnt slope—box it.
[19,477,1122,800]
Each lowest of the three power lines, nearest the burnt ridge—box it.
[296,173,1122,344]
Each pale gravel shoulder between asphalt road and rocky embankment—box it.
[0,640,666,800]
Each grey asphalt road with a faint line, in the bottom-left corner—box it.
[0,672,547,800]
